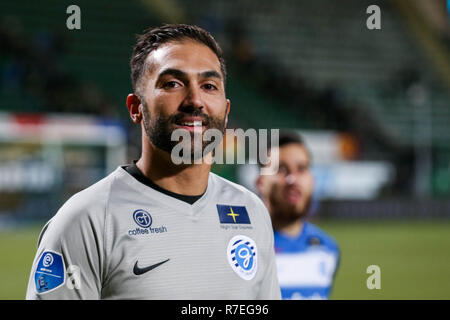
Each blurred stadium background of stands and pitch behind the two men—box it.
[0,0,450,299]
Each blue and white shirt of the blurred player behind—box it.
[274,222,340,299]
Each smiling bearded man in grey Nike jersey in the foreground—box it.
[27,25,281,299]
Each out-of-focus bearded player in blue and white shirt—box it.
[256,132,340,299]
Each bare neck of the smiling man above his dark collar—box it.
[136,141,211,196]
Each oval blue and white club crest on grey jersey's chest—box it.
[227,235,258,280]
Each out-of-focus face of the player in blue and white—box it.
[263,143,314,220]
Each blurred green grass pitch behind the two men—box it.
[0,221,450,299]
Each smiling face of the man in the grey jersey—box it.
[140,40,229,157]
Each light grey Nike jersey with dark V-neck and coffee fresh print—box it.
[26,167,281,299]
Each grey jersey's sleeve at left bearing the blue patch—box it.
[26,197,104,300]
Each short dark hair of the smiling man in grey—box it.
[130,24,226,93]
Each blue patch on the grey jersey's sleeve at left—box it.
[34,250,65,293]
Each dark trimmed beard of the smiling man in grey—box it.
[142,103,225,161]
